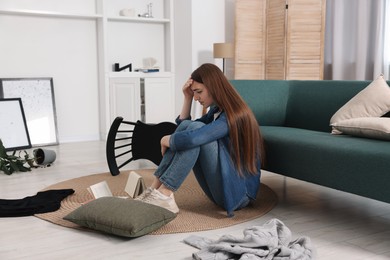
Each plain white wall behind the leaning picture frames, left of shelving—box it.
[0,0,99,142]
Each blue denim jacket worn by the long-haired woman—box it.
[169,107,260,217]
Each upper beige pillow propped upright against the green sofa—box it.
[330,75,390,134]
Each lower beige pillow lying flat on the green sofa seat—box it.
[332,117,390,141]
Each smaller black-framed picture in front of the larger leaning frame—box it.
[0,98,31,151]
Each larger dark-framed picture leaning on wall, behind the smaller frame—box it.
[0,78,58,147]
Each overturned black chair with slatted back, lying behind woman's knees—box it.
[106,117,176,176]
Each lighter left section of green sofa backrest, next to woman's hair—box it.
[231,80,289,126]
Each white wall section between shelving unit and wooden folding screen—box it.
[175,0,232,116]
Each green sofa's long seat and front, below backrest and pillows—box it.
[262,126,390,202]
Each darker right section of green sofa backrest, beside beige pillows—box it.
[285,80,371,132]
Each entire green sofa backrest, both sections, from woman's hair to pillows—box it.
[231,80,382,132]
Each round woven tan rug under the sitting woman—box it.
[35,169,278,235]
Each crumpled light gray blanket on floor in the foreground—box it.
[184,219,314,260]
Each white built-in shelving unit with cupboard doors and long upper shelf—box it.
[0,0,174,139]
